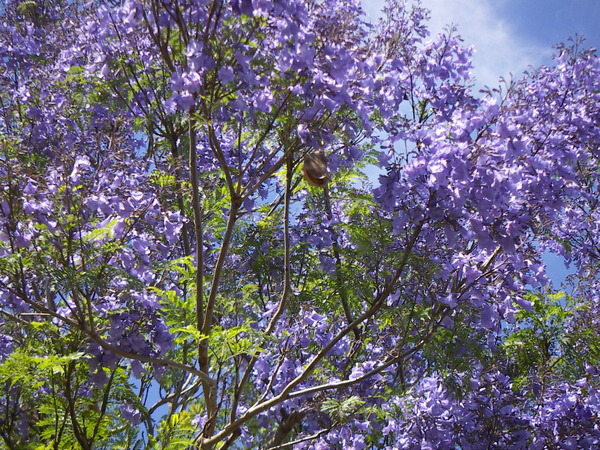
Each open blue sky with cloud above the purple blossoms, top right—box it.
[363,0,600,86]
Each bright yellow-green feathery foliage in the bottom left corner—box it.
[0,336,135,450]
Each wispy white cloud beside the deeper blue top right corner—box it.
[363,0,550,87]
